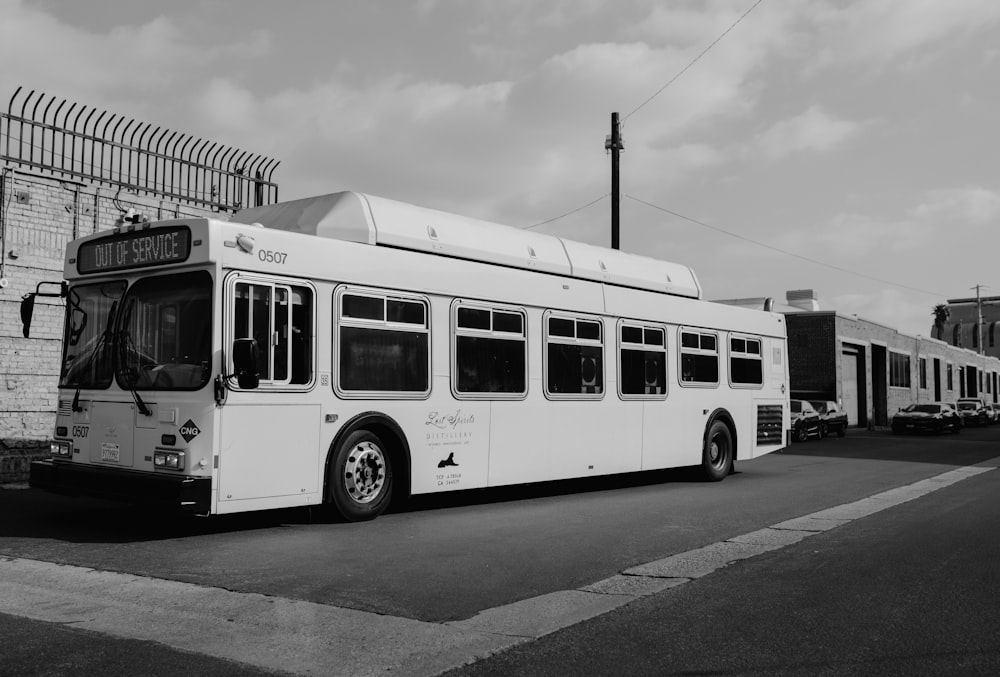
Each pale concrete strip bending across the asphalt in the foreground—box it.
[0,459,996,675]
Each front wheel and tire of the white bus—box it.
[330,429,392,522]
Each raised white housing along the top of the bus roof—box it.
[233,191,701,298]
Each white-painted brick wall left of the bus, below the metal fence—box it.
[0,172,225,483]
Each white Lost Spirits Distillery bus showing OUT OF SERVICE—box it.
[22,192,790,521]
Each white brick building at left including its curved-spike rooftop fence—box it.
[0,89,278,483]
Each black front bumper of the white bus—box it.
[28,459,212,515]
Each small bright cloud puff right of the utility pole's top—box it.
[750,105,865,160]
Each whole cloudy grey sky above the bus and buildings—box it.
[0,0,1000,336]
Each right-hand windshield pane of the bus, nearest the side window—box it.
[115,272,212,390]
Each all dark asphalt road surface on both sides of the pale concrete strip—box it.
[0,427,1000,674]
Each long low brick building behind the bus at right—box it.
[720,289,1000,427]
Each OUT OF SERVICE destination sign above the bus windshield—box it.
[76,226,191,275]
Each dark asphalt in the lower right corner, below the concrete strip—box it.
[448,452,1000,676]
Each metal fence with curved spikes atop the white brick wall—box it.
[0,87,279,211]
